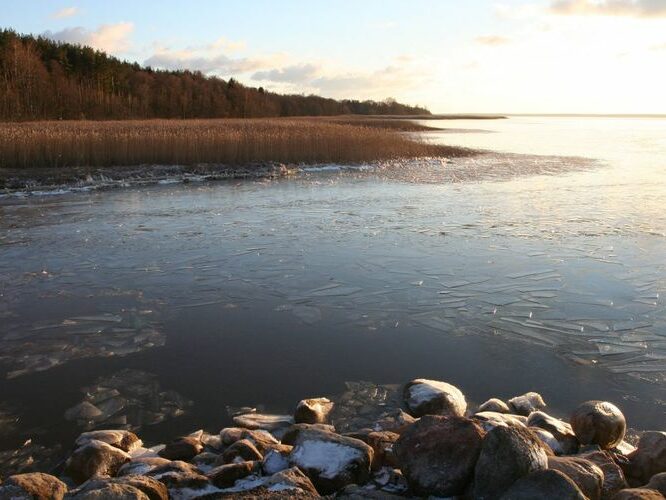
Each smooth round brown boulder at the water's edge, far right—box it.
[570,401,627,449]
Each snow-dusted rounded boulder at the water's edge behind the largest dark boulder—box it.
[403,378,467,417]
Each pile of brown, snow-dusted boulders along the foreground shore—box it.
[0,379,666,500]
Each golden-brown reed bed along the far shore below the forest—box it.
[0,118,469,169]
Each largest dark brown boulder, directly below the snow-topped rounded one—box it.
[395,415,484,496]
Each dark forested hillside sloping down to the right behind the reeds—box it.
[0,30,429,120]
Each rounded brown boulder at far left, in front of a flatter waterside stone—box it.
[65,440,131,483]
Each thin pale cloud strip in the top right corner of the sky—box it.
[550,0,666,17]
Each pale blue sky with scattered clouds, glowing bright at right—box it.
[0,0,666,114]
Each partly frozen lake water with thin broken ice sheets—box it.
[0,117,666,449]
